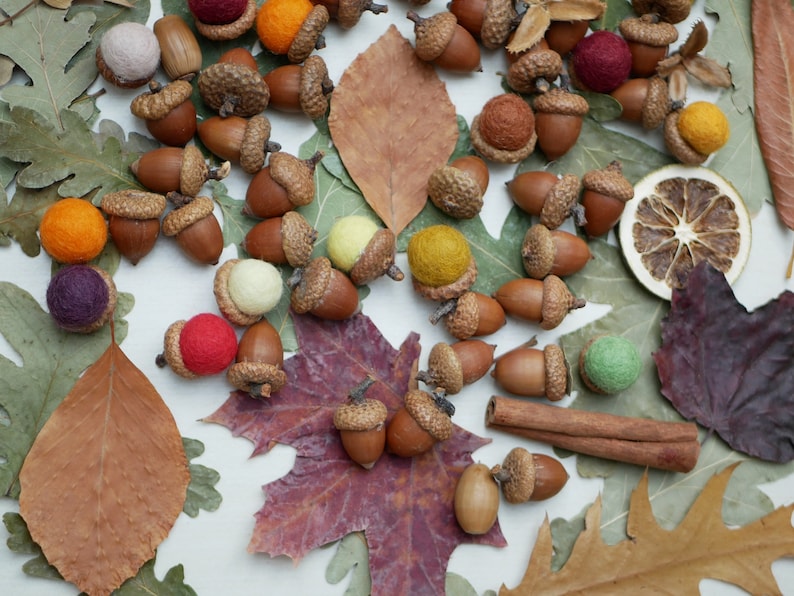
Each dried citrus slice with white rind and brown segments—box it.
[618,164,752,300]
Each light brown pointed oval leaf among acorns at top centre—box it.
[328,25,458,234]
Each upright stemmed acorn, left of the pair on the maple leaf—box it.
[334,377,388,470]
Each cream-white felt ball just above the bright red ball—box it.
[228,259,284,315]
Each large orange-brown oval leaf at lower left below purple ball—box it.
[19,342,190,596]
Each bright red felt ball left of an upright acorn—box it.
[179,313,237,375]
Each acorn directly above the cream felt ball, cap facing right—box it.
[242,211,317,267]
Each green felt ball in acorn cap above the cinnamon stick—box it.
[579,335,642,394]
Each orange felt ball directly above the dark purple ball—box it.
[39,197,108,264]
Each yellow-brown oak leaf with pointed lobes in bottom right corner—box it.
[499,466,794,596]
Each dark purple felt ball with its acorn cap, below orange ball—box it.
[47,265,113,333]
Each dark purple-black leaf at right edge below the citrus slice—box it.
[654,262,794,463]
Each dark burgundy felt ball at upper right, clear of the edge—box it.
[572,30,631,93]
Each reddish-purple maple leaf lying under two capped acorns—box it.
[204,314,504,594]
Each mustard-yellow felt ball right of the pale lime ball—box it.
[407,225,471,288]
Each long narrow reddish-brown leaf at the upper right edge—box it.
[751,0,794,229]
